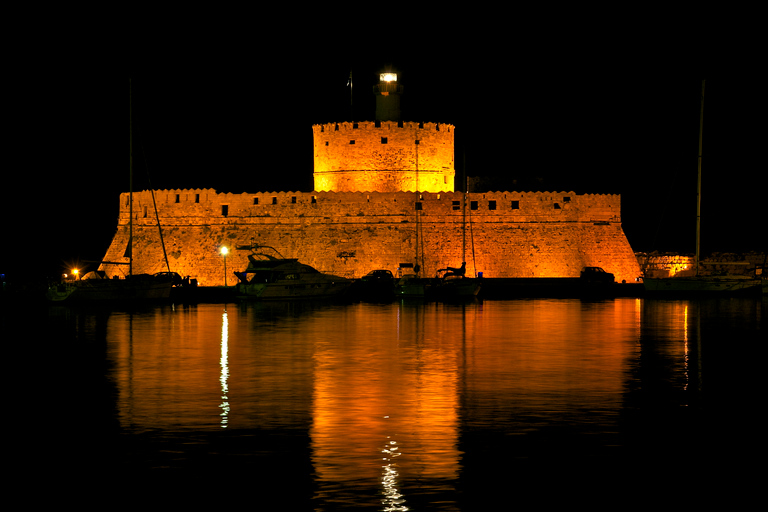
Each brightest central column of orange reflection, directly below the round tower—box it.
[311,307,462,490]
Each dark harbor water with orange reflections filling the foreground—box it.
[12,298,766,511]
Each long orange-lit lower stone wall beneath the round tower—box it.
[102,189,640,286]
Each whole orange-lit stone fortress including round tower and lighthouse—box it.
[100,69,641,286]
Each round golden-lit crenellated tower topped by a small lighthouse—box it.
[312,73,456,192]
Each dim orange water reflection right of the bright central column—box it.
[464,300,639,430]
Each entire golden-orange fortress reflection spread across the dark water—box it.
[103,299,672,502]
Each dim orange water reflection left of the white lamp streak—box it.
[107,307,231,431]
